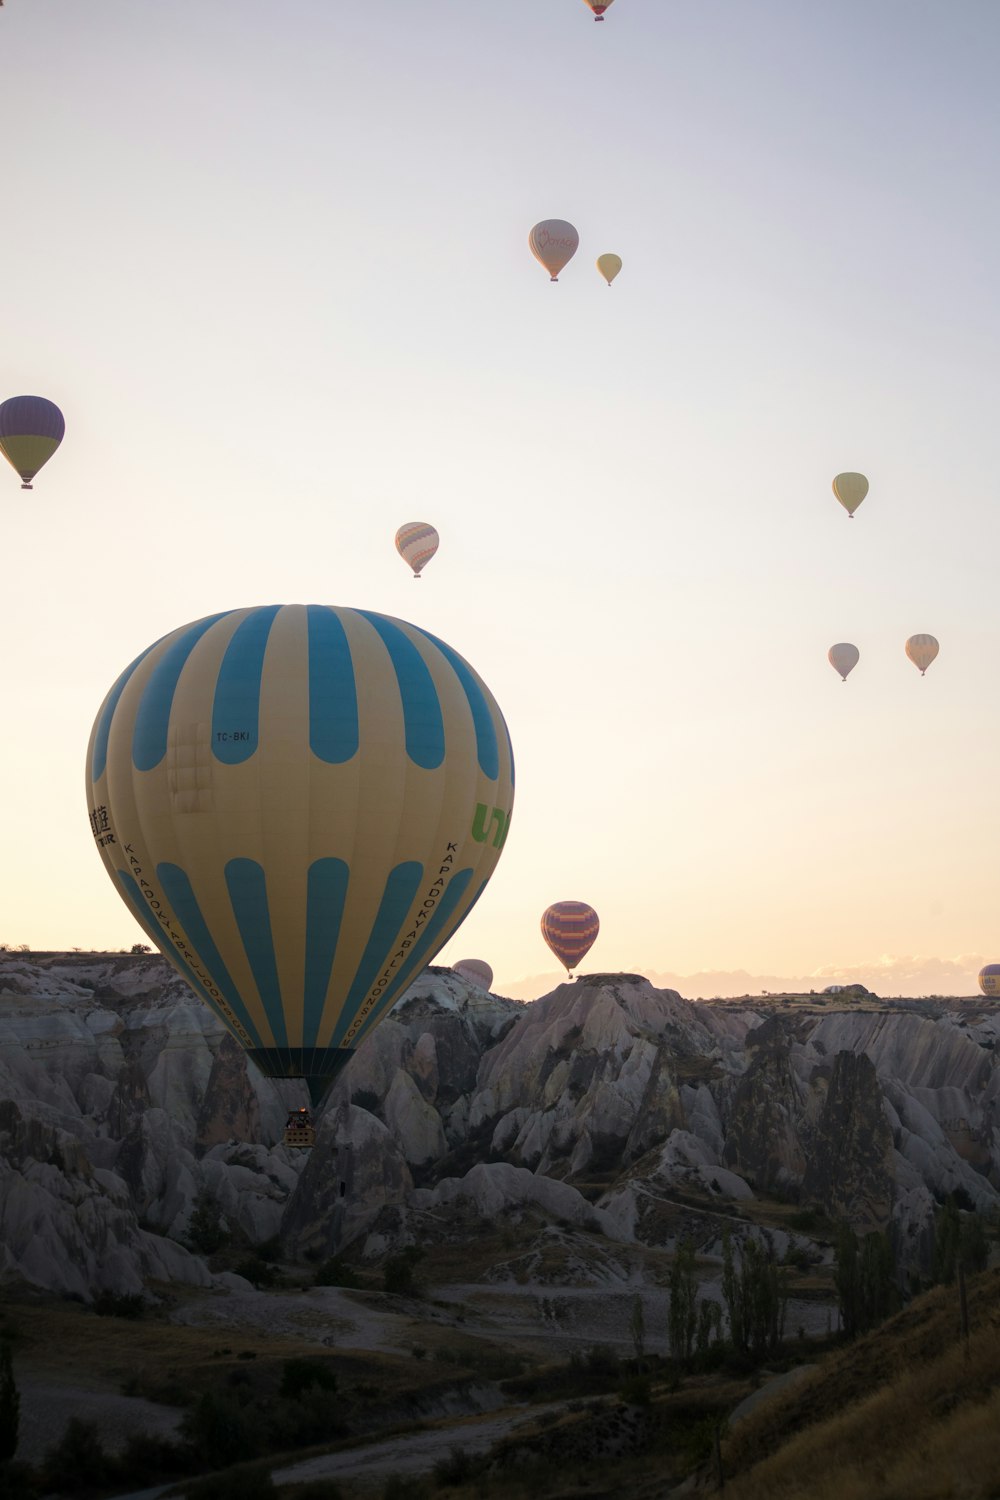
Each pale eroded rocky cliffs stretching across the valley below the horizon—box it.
[0,954,1000,1298]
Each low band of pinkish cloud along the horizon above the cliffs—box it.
[493,953,987,1001]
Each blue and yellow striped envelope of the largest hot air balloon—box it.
[87,605,514,1103]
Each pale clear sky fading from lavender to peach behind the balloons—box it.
[0,0,1000,993]
